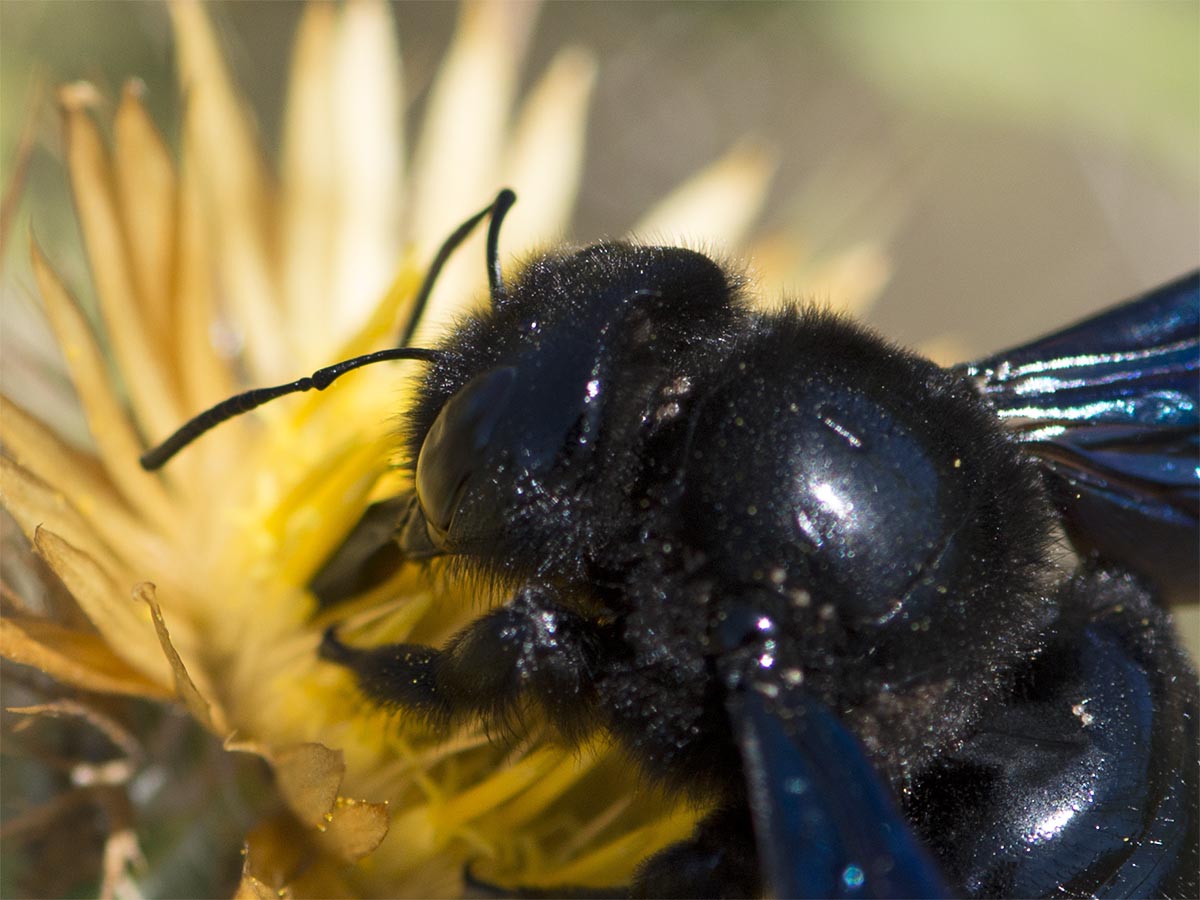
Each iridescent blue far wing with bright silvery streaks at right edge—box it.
[960,272,1200,599]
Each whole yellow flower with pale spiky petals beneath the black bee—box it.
[0,2,886,896]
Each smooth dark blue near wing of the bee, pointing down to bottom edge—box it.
[726,674,948,898]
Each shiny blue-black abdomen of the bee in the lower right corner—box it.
[907,570,1200,898]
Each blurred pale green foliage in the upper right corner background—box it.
[824,0,1200,182]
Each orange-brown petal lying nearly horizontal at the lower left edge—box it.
[0,616,173,700]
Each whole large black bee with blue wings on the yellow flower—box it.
[143,191,1200,898]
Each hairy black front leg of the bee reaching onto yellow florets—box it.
[320,586,599,737]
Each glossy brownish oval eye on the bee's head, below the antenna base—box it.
[416,366,516,534]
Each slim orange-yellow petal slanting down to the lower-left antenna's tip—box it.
[32,244,175,534]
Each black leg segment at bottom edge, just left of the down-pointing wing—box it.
[629,806,762,898]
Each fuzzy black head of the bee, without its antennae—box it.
[401,242,737,577]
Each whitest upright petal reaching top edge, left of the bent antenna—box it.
[326,0,404,341]
